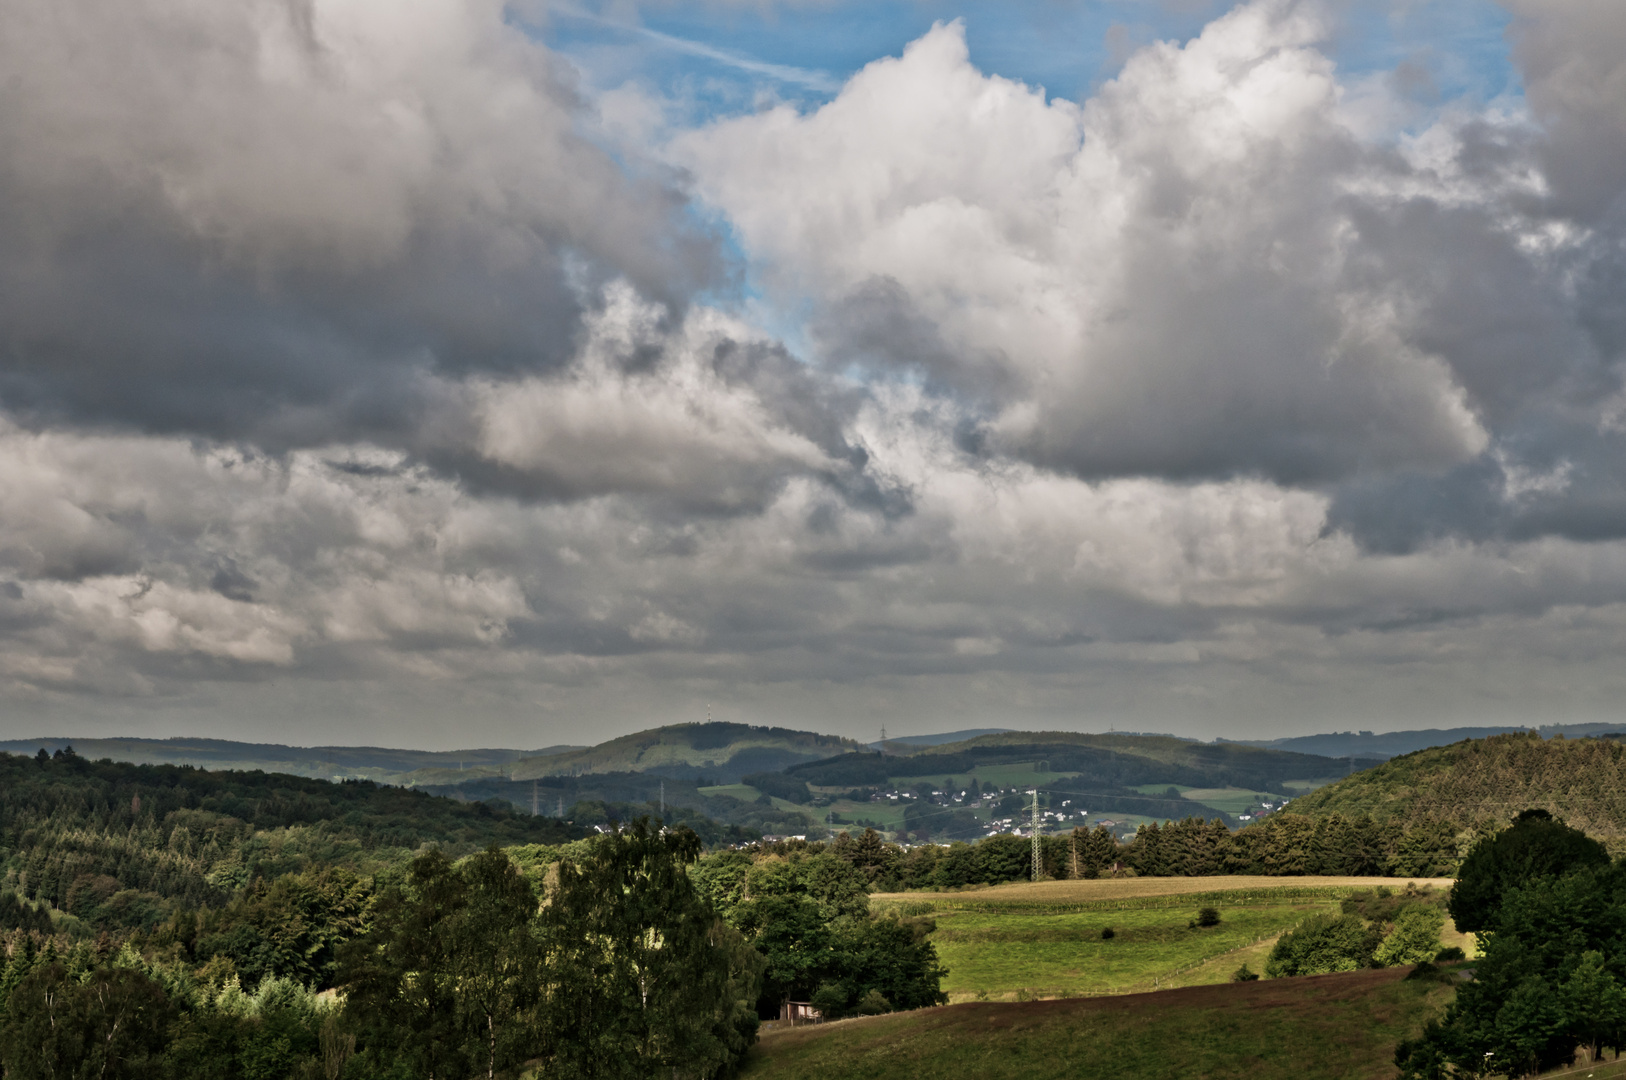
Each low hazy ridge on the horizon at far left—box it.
[0,738,580,784]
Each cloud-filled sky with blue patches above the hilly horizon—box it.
[0,0,1626,748]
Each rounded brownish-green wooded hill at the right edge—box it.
[1293,732,1626,849]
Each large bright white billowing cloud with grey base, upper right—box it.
[673,0,1619,485]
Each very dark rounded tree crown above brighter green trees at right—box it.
[1446,810,1610,934]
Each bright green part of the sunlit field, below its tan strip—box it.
[932,896,1338,1000]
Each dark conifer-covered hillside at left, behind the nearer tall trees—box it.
[0,750,584,924]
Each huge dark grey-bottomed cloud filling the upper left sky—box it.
[0,0,719,446]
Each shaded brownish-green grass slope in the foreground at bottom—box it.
[743,968,1452,1080]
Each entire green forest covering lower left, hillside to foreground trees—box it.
[0,750,941,1080]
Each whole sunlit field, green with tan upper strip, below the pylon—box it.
[872,877,1472,1002]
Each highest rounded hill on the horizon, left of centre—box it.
[509,722,860,784]
